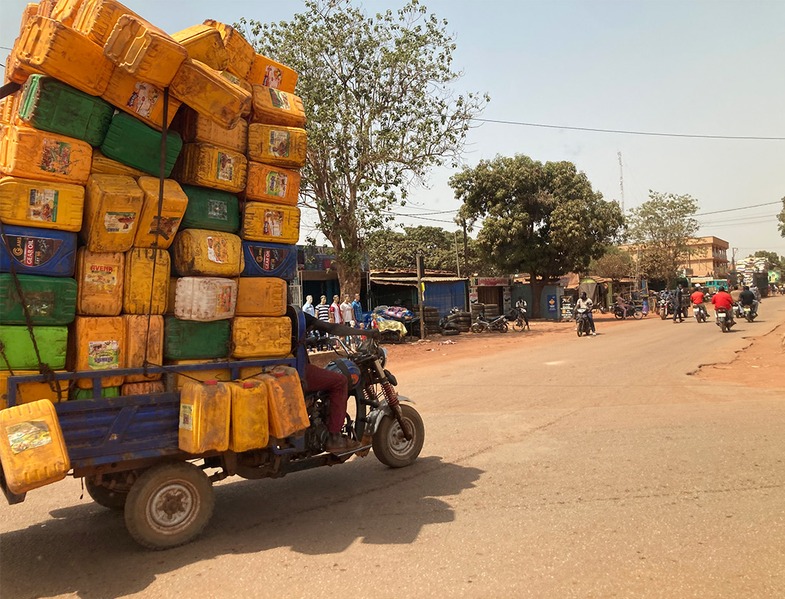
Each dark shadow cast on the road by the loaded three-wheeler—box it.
[0,456,483,599]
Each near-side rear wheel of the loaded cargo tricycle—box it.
[125,462,215,549]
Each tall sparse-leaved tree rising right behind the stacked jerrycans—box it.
[238,0,488,294]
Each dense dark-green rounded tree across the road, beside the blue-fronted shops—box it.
[450,154,624,312]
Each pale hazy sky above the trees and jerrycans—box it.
[0,0,785,259]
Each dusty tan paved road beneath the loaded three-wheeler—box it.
[0,298,785,599]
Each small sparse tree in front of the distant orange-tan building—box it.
[628,190,698,283]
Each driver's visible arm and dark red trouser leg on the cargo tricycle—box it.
[303,314,379,453]
